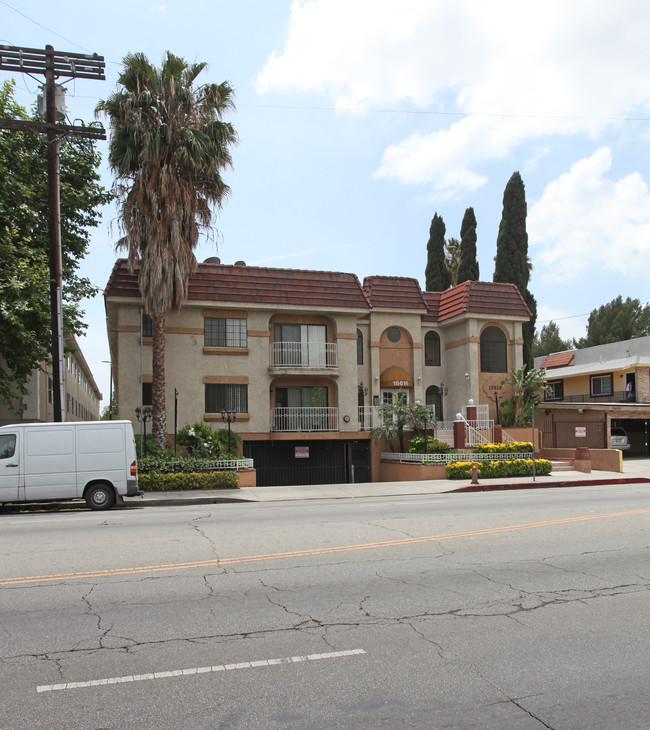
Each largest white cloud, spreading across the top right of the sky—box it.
[257,0,650,195]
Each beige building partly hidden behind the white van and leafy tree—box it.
[0,335,102,426]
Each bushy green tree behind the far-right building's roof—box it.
[574,295,650,348]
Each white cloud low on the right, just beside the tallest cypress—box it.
[527,147,650,281]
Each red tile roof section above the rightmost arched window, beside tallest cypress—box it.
[438,281,531,322]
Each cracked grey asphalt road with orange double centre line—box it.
[0,484,650,730]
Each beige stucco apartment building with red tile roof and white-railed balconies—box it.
[104,259,530,485]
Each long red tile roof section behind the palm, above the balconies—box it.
[104,259,368,309]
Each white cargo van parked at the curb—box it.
[0,421,141,510]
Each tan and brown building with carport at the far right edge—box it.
[535,337,650,456]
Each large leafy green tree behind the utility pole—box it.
[0,81,111,408]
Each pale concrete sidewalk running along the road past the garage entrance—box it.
[124,459,650,506]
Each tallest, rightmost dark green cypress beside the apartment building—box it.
[493,172,537,368]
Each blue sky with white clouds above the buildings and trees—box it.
[5,0,650,401]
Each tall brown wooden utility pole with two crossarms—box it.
[0,45,106,421]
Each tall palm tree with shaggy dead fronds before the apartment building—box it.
[95,51,237,450]
